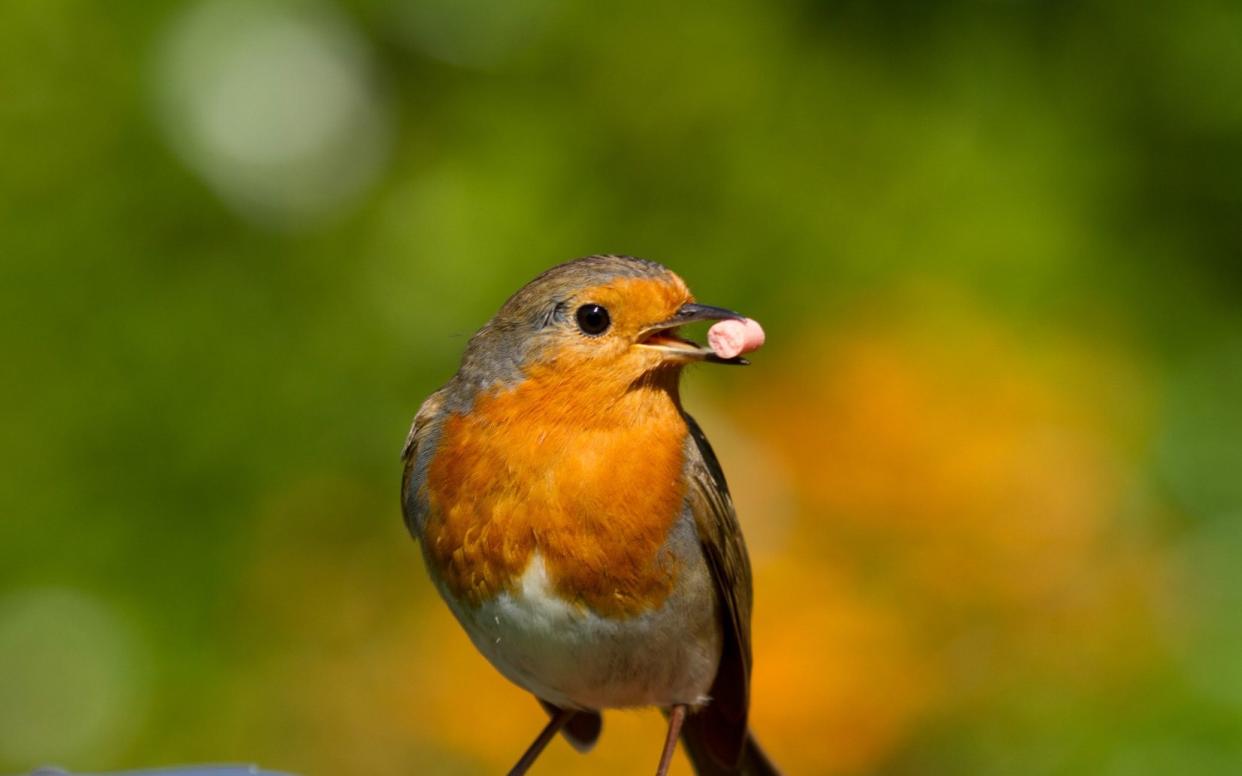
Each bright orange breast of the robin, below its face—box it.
[424,365,687,616]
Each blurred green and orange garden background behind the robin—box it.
[0,0,1242,776]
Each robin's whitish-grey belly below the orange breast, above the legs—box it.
[447,526,720,709]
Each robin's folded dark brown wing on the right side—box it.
[686,415,751,766]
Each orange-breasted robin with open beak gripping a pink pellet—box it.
[401,256,776,776]
